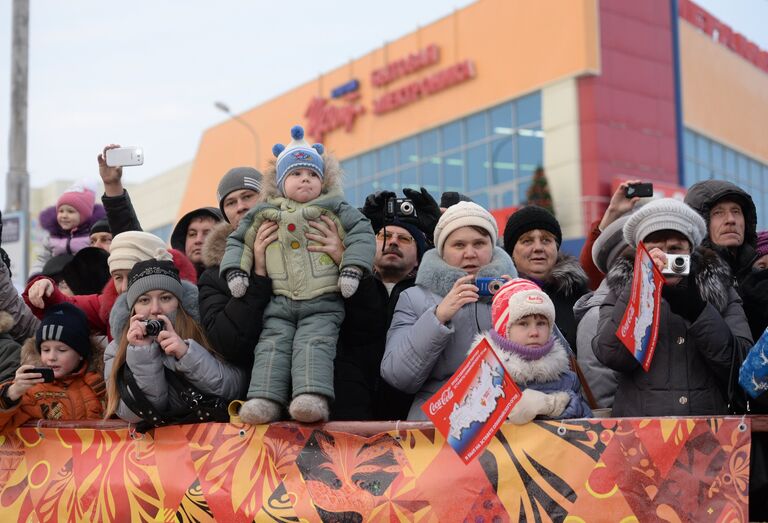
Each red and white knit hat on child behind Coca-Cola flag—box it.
[491,278,555,337]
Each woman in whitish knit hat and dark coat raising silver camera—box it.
[592,199,752,416]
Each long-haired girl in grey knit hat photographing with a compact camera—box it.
[104,260,246,429]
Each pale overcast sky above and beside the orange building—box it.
[0,0,768,208]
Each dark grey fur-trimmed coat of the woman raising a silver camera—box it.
[592,247,752,417]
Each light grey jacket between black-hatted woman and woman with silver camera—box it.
[573,280,619,409]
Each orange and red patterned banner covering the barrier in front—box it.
[0,418,751,522]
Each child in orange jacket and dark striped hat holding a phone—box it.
[0,303,104,432]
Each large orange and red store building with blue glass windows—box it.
[179,0,768,252]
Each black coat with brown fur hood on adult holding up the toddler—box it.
[197,222,272,375]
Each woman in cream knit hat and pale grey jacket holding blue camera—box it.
[381,202,517,420]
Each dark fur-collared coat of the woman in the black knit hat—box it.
[520,253,589,352]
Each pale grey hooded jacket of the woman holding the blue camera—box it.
[381,247,517,420]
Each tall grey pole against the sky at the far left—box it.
[5,0,29,216]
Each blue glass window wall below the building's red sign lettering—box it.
[343,92,544,209]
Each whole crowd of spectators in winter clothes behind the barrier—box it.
[0,138,768,516]
